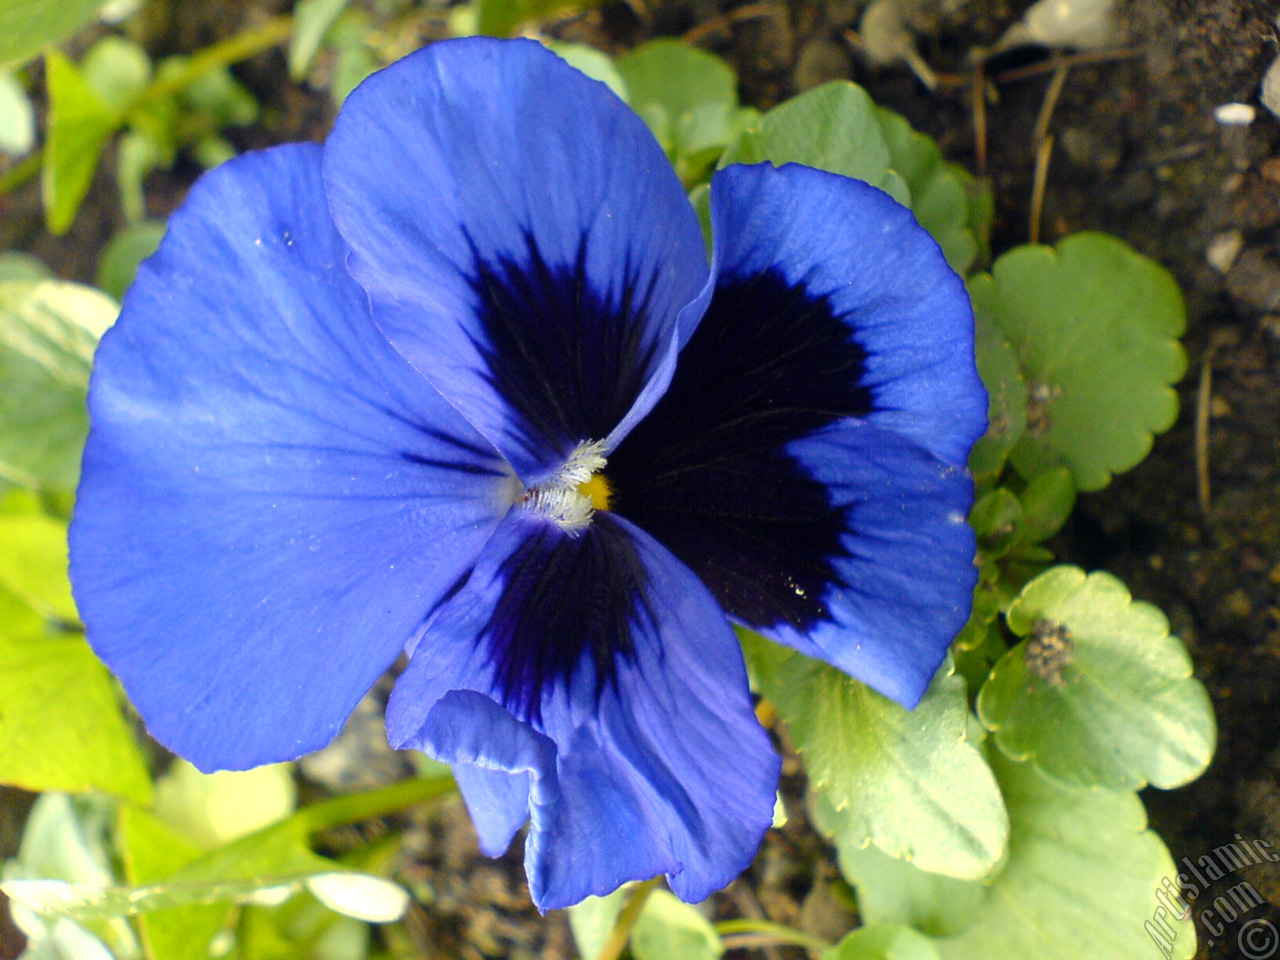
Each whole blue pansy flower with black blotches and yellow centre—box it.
[72,38,986,909]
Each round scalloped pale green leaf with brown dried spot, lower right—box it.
[978,567,1216,790]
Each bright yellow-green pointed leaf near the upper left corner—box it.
[40,50,124,234]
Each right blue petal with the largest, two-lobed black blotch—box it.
[605,166,986,703]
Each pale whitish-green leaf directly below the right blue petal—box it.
[763,653,1009,878]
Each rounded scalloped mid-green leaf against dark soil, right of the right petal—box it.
[970,233,1187,490]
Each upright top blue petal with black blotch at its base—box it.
[325,38,709,485]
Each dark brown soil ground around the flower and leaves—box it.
[0,0,1280,960]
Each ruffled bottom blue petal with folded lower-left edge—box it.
[388,509,778,910]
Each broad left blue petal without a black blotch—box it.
[70,146,515,769]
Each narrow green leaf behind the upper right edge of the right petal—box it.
[877,106,984,274]
